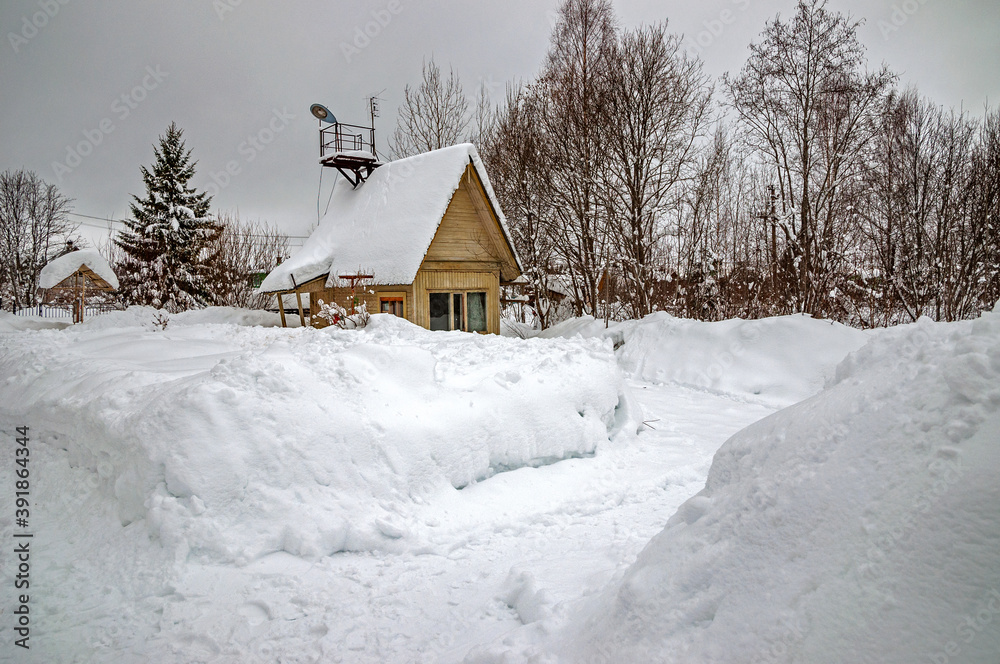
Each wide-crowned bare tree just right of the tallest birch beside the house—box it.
[604,23,712,318]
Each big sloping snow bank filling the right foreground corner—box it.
[478,307,1000,664]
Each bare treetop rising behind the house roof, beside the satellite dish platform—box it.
[390,57,471,159]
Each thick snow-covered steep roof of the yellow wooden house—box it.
[258,143,520,293]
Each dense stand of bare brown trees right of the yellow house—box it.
[450,0,1000,327]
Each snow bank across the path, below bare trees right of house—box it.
[539,312,870,406]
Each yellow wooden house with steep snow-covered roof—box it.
[259,144,521,334]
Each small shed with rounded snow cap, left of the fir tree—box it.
[38,249,118,323]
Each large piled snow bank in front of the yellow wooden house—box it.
[0,309,635,562]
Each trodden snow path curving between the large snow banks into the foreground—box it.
[19,378,770,662]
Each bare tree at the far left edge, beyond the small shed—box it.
[0,170,79,312]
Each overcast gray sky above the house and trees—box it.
[0,0,1000,246]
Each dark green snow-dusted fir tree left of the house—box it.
[115,122,220,312]
